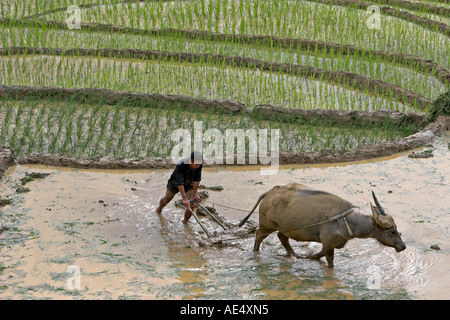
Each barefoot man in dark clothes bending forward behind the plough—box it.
[156,151,203,223]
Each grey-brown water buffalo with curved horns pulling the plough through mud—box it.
[239,182,406,267]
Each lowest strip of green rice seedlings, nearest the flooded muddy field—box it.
[0,96,415,157]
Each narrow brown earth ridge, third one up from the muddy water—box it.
[0,47,432,110]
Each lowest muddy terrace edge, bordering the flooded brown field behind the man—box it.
[0,116,450,179]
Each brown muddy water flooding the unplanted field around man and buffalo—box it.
[0,134,450,299]
